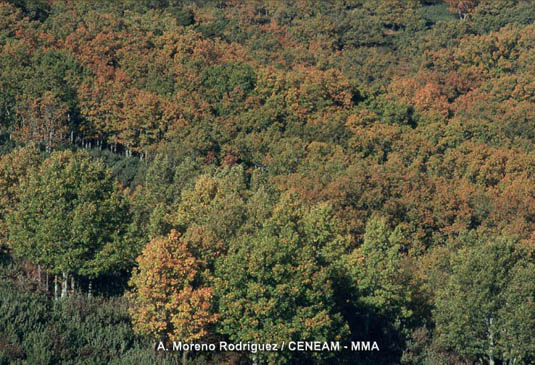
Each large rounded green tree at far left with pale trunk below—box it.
[8,151,131,295]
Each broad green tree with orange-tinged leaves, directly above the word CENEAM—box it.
[214,194,348,363]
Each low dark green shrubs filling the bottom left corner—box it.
[0,268,159,364]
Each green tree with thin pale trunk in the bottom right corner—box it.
[434,237,535,364]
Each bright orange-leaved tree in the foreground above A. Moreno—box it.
[128,230,218,342]
